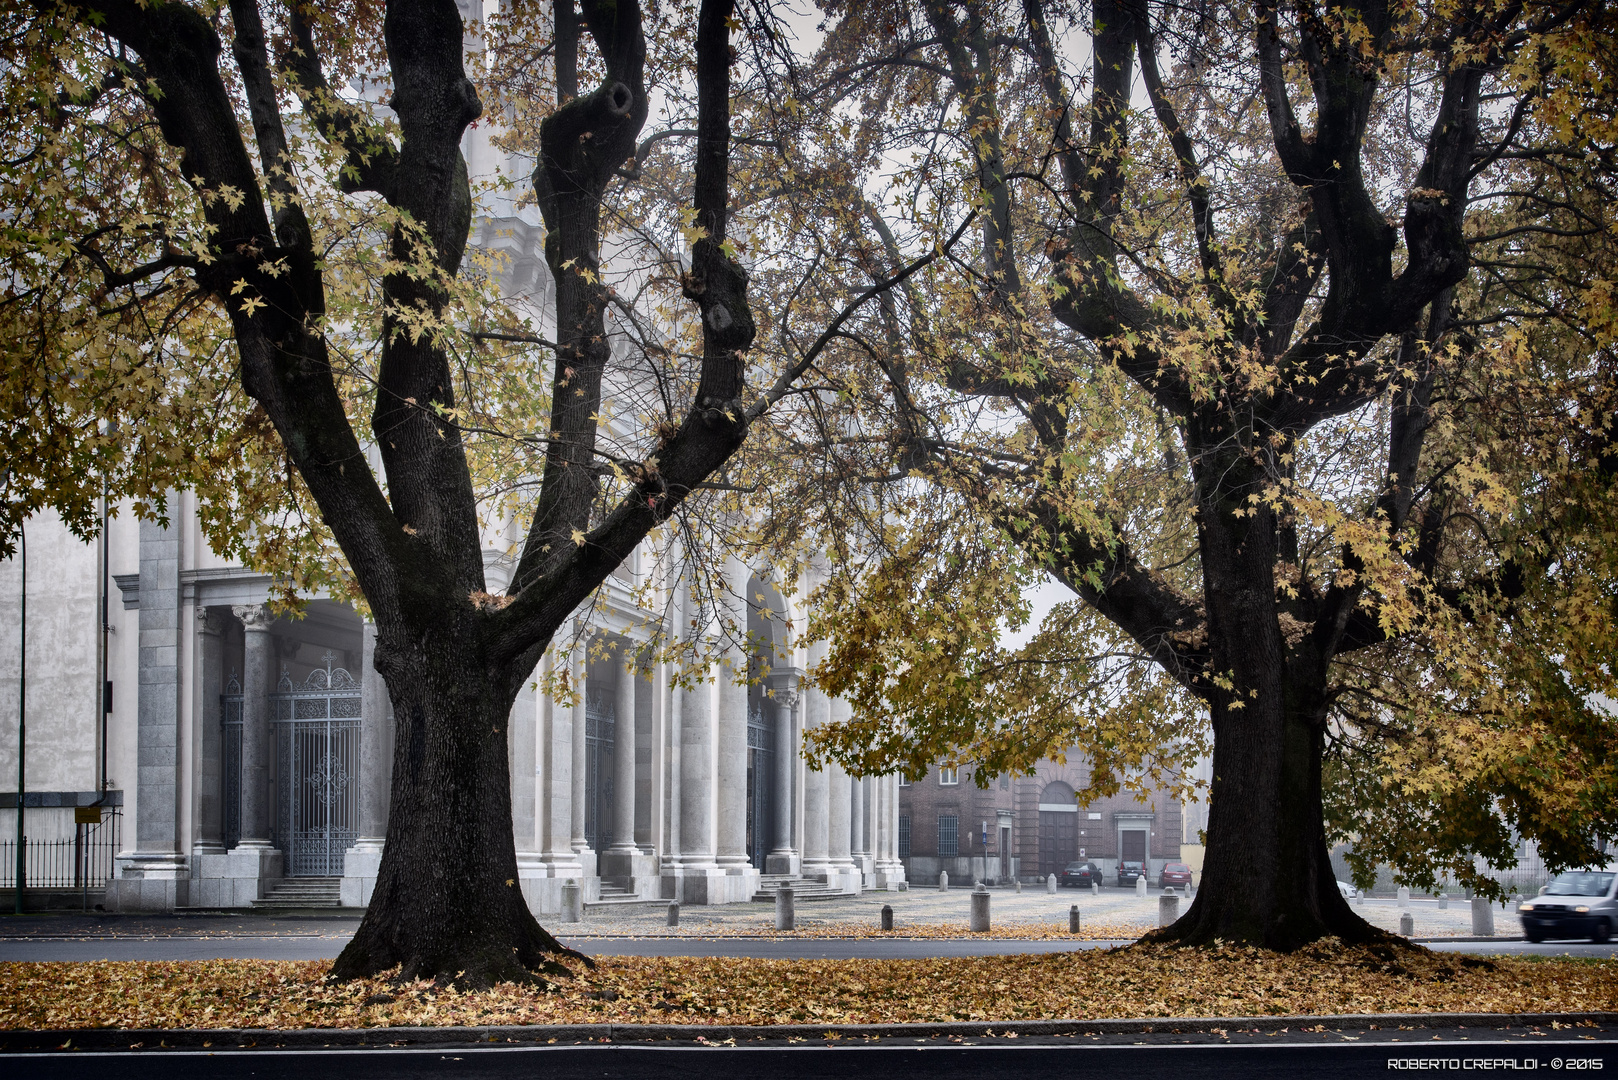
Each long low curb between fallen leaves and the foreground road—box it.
[0,1012,1618,1052]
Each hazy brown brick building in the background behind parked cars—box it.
[898,753,1184,886]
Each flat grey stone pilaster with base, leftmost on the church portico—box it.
[105,521,191,912]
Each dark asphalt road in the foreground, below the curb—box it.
[0,1031,1618,1080]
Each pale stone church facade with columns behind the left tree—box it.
[0,492,904,918]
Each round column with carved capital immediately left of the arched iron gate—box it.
[227,604,283,907]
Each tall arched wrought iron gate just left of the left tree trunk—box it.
[270,653,359,878]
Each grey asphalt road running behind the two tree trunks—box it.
[0,931,1618,960]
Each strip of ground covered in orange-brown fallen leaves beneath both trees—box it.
[0,942,1618,1028]
